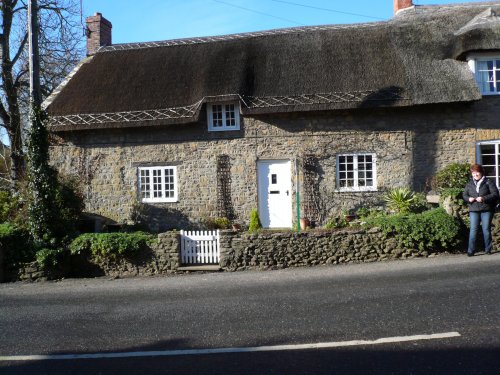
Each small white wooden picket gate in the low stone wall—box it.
[181,230,220,264]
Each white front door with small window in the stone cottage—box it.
[257,160,292,228]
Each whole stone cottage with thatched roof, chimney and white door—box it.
[45,0,500,230]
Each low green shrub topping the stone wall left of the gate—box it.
[69,232,156,260]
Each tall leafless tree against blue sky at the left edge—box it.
[0,0,83,186]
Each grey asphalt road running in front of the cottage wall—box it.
[0,253,500,374]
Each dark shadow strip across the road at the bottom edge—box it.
[0,341,500,375]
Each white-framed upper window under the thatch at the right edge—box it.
[469,53,500,95]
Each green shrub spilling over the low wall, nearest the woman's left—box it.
[367,208,461,250]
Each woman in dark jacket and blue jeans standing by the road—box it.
[463,164,498,257]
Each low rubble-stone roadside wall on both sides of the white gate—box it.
[0,228,468,281]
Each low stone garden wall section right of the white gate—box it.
[221,229,460,271]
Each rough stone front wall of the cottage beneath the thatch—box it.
[51,97,500,231]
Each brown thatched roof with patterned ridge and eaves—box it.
[48,1,500,130]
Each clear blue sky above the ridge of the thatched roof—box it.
[81,0,492,44]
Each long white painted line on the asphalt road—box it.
[0,332,461,362]
